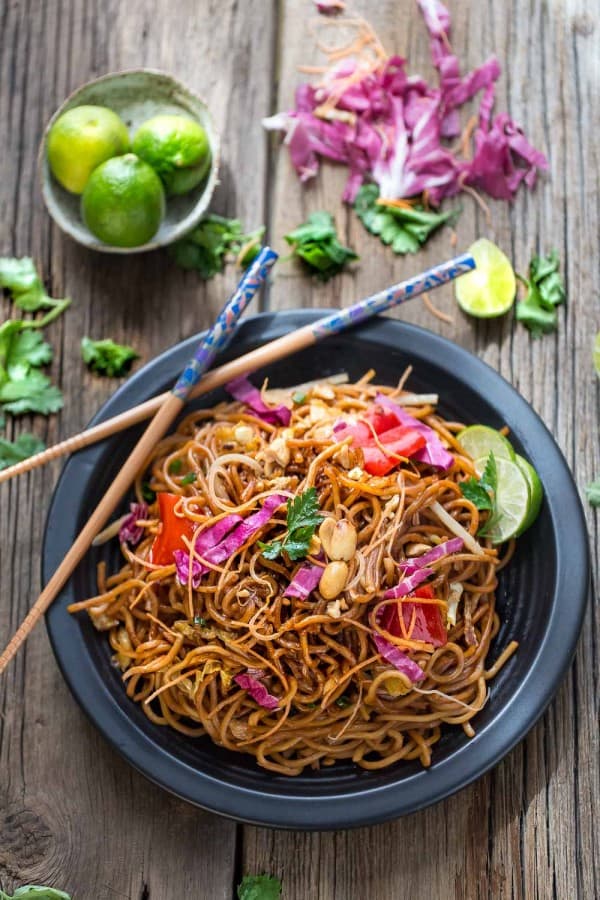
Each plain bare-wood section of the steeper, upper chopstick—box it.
[0,393,183,674]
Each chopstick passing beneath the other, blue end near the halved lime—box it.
[0,254,475,483]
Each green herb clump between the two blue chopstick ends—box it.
[285,211,358,281]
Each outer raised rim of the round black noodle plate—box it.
[42,309,590,830]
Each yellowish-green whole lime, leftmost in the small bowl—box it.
[46,106,129,194]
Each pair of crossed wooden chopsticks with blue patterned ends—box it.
[0,247,475,674]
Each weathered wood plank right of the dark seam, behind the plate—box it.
[244,0,600,900]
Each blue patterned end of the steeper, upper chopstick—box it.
[172,247,278,401]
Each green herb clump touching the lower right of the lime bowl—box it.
[169,213,265,280]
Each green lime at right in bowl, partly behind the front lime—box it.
[132,115,210,194]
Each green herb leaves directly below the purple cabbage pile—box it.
[354,184,460,253]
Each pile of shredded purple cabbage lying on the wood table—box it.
[263,0,548,205]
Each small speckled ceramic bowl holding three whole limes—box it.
[39,69,219,253]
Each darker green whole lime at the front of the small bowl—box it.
[81,153,165,247]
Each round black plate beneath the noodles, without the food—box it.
[43,310,590,829]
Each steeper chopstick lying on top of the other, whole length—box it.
[0,247,277,674]
